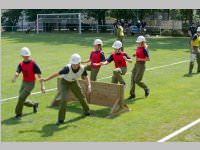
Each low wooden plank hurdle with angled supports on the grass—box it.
[51,78,130,117]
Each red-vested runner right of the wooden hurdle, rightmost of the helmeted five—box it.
[128,36,150,99]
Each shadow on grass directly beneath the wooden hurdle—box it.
[47,103,111,118]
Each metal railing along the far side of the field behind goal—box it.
[1,24,162,35]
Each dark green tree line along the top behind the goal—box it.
[1,9,200,26]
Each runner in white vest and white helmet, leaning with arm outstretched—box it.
[41,54,91,125]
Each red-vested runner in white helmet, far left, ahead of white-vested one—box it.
[12,47,45,119]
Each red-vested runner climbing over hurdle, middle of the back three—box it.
[95,41,132,87]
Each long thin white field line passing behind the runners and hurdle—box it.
[0,60,188,103]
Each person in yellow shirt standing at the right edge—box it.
[189,27,200,75]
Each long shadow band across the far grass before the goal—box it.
[2,33,189,51]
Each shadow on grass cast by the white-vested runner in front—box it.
[19,116,85,137]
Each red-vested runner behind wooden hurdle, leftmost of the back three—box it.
[82,39,105,81]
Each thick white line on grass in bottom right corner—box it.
[157,118,200,143]
